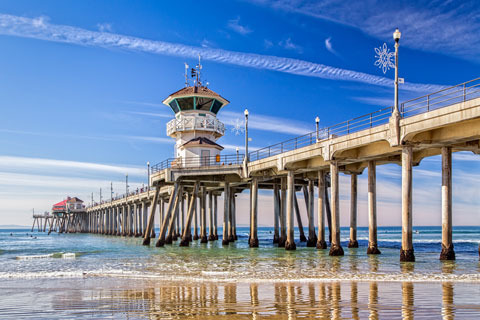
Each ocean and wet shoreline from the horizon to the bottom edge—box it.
[0,227,480,319]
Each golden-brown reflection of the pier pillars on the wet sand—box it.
[44,278,472,320]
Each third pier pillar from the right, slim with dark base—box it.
[367,160,380,254]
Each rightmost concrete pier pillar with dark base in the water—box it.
[440,147,455,260]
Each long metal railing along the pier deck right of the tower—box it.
[248,78,480,161]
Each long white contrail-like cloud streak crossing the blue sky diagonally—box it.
[0,14,444,93]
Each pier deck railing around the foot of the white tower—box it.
[151,154,245,173]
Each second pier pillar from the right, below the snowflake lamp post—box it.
[400,146,415,261]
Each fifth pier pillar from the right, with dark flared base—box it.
[329,161,344,256]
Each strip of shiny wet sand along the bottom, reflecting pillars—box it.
[0,278,480,319]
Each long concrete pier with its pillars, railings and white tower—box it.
[38,78,480,261]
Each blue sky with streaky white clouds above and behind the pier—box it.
[0,0,480,225]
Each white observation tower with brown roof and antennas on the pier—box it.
[163,57,229,167]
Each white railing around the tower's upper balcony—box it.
[167,115,225,135]
